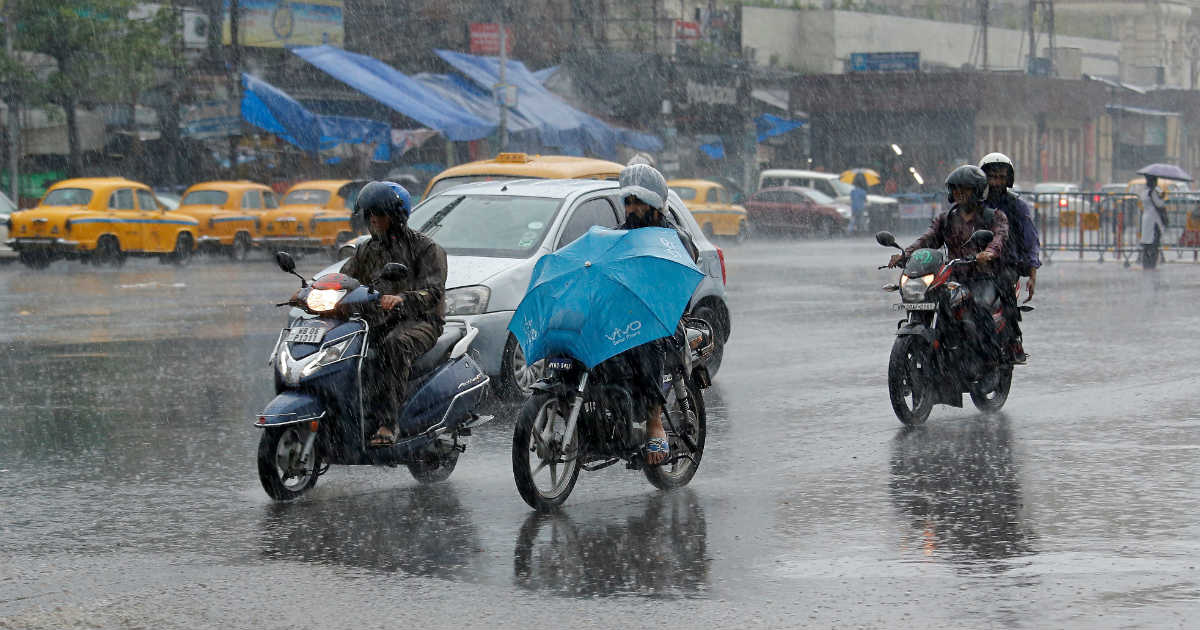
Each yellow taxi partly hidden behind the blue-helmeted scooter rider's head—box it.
[254,179,366,254]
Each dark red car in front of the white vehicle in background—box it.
[746,186,850,236]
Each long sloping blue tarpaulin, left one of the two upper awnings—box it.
[292,46,496,142]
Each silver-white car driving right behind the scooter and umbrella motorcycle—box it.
[300,180,731,398]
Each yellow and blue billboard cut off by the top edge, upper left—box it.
[222,0,343,48]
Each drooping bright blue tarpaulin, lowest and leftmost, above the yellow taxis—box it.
[241,73,391,162]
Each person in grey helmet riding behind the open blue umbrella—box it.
[610,163,698,466]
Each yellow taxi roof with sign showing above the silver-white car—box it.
[425,154,624,197]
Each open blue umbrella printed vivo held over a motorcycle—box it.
[509,227,704,370]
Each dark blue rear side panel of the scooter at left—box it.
[400,354,488,436]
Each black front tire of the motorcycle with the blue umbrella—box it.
[512,391,580,512]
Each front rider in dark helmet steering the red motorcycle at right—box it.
[888,164,1008,354]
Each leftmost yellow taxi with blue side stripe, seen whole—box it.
[8,178,199,269]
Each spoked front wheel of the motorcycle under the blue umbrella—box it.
[512,391,580,512]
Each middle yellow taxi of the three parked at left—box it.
[175,181,280,260]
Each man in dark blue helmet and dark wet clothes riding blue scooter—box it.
[342,181,446,446]
